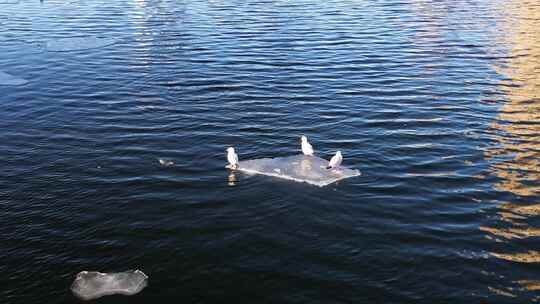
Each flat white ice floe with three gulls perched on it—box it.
[238,155,360,187]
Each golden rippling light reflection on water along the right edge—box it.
[480,1,540,300]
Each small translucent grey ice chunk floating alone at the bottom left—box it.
[71,270,148,300]
